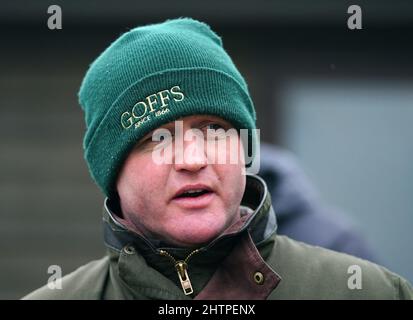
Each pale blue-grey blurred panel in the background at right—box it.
[277,79,413,281]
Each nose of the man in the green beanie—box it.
[174,132,208,172]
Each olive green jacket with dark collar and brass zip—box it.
[24,176,413,300]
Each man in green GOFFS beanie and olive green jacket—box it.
[26,18,413,299]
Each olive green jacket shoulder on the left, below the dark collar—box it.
[22,257,109,300]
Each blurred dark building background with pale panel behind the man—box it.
[0,0,413,299]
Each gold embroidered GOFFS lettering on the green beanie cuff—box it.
[120,86,185,129]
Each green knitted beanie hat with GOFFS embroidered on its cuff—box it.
[79,18,256,197]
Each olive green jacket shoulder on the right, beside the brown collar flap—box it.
[266,236,413,300]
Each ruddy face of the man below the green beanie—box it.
[117,115,246,247]
